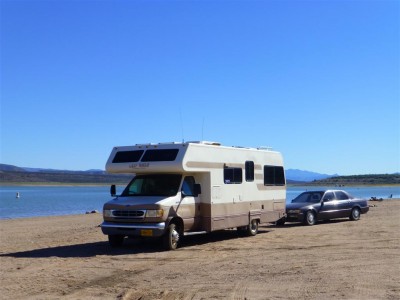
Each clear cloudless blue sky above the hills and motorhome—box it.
[0,0,400,175]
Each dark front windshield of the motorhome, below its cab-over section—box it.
[121,174,182,196]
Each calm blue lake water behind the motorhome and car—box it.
[0,186,400,219]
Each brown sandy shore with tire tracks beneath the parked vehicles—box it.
[0,200,400,300]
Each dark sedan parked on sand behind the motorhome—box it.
[280,190,369,225]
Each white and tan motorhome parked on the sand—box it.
[101,141,286,250]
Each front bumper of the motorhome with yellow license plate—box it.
[100,222,165,237]
